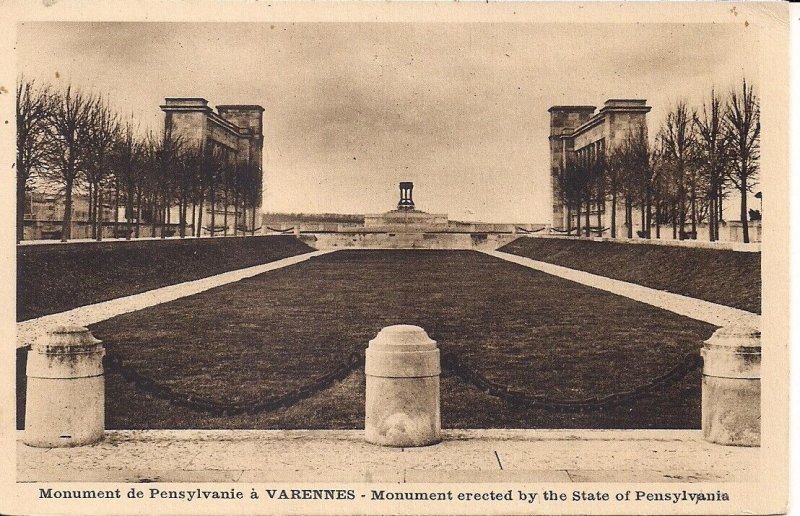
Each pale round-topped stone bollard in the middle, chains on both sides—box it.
[364,324,442,446]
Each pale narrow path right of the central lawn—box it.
[480,251,761,328]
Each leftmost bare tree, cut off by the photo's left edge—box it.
[16,77,52,242]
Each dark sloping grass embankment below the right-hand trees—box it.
[499,237,761,313]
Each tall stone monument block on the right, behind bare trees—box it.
[548,99,650,234]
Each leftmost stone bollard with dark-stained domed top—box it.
[23,326,105,448]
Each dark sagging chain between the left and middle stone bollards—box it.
[104,352,364,416]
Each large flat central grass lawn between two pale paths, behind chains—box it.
[28,250,715,429]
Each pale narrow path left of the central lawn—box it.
[17,250,332,347]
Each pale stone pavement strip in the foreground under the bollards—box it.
[17,430,761,483]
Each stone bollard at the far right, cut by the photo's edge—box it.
[701,325,761,446]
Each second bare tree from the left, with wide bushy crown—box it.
[48,86,95,242]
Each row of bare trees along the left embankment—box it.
[16,78,262,241]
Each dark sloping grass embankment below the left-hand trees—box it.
[17,236,313,321]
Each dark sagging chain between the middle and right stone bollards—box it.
[442,353,703,412]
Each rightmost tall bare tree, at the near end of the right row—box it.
[725,79,761,243]
